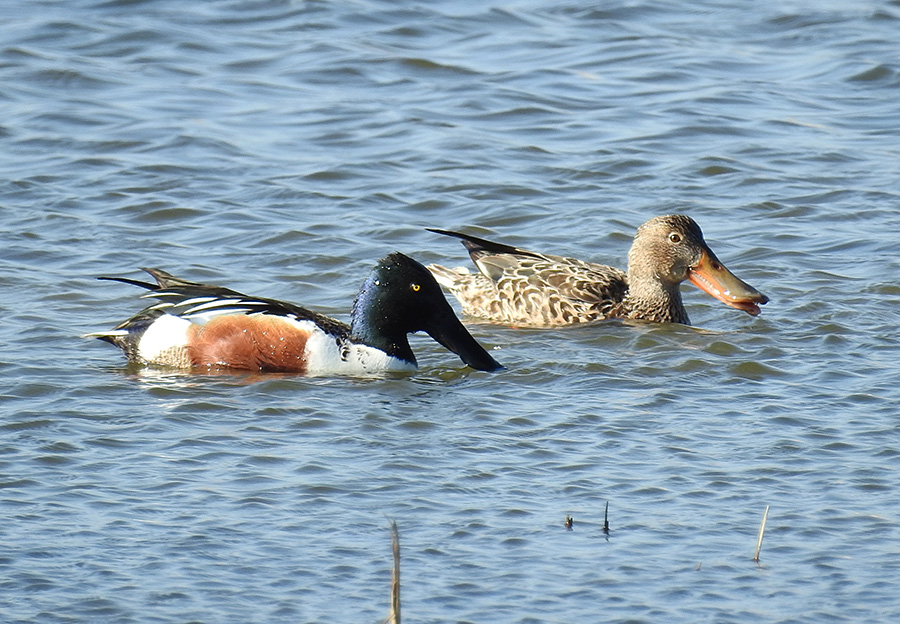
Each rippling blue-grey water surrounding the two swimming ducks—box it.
[0,0,900,624]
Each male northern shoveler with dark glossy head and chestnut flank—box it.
[88,253,501,375]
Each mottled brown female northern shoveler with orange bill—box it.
[428,215,769,327]
